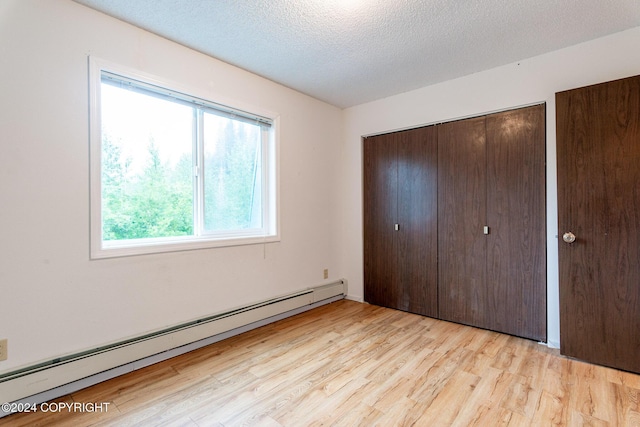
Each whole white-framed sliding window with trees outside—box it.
[91,59,278,258]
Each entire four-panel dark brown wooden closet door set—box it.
[363,105,546,341]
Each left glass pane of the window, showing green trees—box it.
[101,83,194,241]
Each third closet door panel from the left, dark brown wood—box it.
[438,117,489,328]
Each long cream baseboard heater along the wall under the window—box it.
[0,280,347,410]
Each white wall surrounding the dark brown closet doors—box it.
[340,27,640,347]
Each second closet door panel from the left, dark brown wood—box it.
[394,126,438,317]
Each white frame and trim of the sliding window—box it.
[89,56,280,259]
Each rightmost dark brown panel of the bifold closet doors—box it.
[485,105,547,341]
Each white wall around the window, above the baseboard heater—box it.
[0,0,342,373]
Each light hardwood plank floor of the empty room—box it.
[0,300,640,427]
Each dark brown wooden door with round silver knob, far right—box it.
[556,76,640,372]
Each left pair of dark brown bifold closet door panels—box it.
[363,127,438,317]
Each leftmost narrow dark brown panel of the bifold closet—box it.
[363,135,399,307]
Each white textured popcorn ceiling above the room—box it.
[75,0,640,108]
